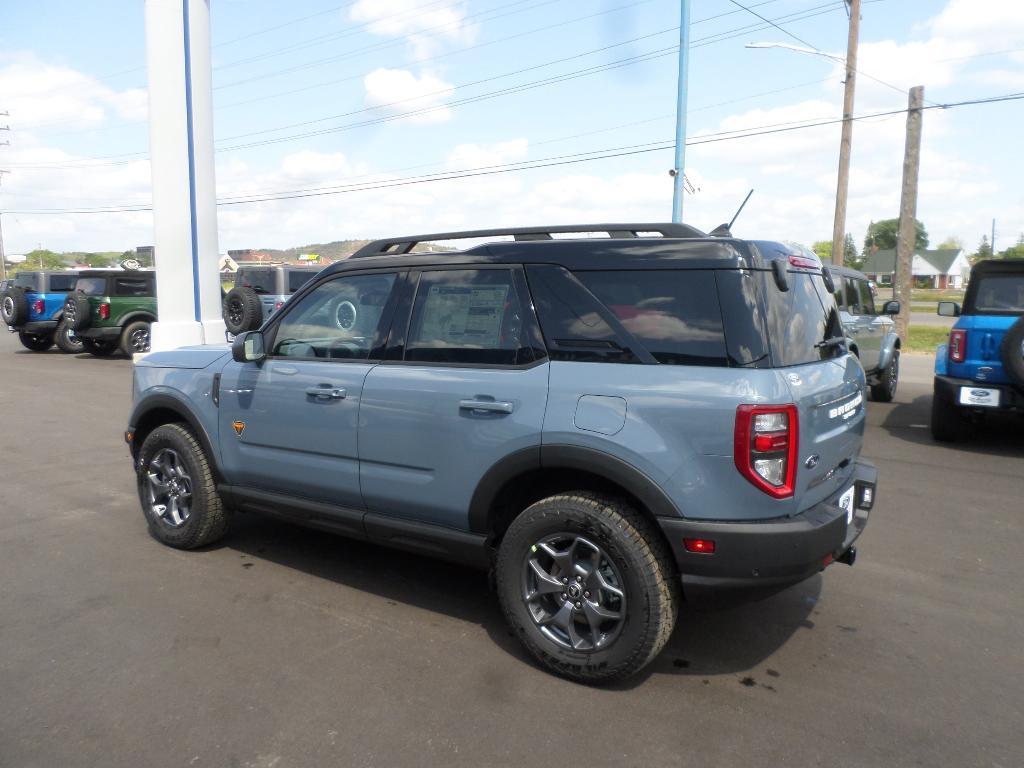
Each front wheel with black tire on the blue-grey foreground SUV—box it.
[136,424,231,549]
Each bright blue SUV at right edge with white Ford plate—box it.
[932,259,1024,441]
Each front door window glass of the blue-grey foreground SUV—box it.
[270,273,395,360]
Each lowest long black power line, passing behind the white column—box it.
[10,92,1024,215]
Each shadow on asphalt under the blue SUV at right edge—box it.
[881,394,1024,458]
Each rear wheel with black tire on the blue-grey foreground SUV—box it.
[497,492,680,683]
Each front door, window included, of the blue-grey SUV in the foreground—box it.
[219,272,395,508]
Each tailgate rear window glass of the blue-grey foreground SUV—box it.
[761,271,846,368]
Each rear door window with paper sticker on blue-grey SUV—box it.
[406,269,532,366]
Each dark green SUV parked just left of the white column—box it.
[65,269,157,356]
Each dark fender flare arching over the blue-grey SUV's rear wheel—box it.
[469,444,682,534]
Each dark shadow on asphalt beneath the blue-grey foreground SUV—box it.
[224,514,821,690]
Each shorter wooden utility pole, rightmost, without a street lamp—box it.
[893,85,925,342]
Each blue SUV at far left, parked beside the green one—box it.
[0,271,82,352]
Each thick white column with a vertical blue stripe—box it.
[145,0,224,351]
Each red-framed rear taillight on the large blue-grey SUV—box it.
[733,406,800,499]
